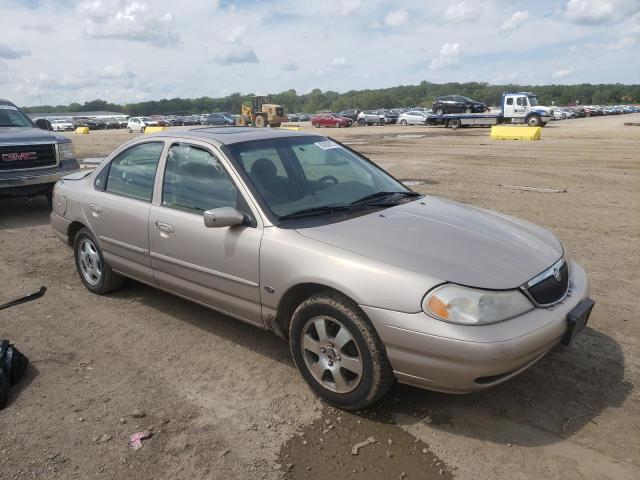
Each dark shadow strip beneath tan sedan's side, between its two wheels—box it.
[111,280,294,368]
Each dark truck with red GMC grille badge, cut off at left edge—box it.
[0,99,80,201]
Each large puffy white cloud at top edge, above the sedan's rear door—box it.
[78,0,177,46]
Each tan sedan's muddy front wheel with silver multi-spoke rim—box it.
[289,292,394,410]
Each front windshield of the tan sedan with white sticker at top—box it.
[228,136,411,218]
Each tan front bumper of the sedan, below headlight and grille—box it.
[361,262,589,393]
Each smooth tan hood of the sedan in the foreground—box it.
[298,197,563,290]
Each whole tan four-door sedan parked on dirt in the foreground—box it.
[51,127,593,409]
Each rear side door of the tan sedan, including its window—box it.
[82,141,164,283]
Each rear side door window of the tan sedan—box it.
[105,142,164,202]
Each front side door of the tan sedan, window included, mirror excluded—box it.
[149,142,262,325]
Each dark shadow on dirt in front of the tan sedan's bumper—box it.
[370,328,632,446]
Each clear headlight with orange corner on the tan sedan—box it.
[423,284,533,325]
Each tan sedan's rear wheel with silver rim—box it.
[73,228,124,294]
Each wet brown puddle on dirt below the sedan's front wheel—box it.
[278,406,453,480]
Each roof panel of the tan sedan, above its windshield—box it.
[146,127,318,145]
